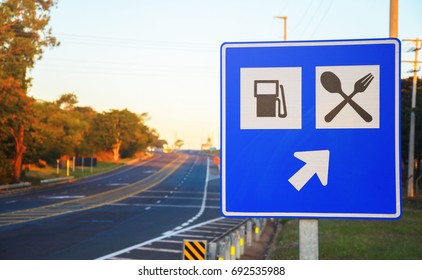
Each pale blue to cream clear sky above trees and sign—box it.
[29,0,422,149]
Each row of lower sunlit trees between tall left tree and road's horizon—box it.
[26,94,162,164]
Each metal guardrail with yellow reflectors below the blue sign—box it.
[207,218,267,260]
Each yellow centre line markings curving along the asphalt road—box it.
[0,154,189,227]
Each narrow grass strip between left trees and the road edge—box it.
[22,162,124,185]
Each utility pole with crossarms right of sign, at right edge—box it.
[403,38,422,197]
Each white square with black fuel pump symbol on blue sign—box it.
[240,67,302,129]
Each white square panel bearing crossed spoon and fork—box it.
[316,65,380,128]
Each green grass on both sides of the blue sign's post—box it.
[270,201,422,260]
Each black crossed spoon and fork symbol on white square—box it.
[321,71,374,123]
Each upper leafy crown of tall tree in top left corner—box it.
[0,0,58,82]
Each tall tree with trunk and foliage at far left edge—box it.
[0,0,58,181]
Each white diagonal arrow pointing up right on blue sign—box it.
[289,150,330,191]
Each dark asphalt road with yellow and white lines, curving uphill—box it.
[0,152,227,260]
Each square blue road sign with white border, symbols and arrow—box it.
[221,39,401,219]
